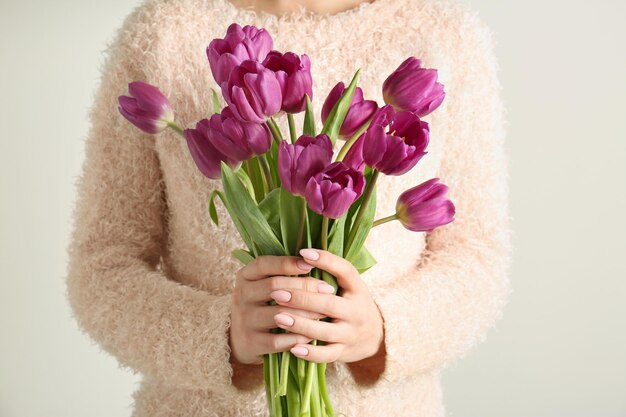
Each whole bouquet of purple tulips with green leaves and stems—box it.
[119,23,455,417]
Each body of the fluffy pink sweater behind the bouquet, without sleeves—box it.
[134,0,449,417]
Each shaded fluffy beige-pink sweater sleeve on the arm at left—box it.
[66,7,261,396]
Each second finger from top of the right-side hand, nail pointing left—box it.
[270,289,350,320]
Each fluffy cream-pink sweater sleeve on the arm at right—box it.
[360,11,512,380]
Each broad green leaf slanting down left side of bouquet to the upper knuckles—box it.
[222,162,285,255]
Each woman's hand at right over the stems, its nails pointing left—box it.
[271,249,384,363]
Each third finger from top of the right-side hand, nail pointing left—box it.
[274,312,352,343]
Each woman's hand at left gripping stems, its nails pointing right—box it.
[229,256,333,365]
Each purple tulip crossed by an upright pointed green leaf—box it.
[322,81,378,139]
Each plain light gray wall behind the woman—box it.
[0,0,626,417]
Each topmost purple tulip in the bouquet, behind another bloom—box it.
[206,23,274,86]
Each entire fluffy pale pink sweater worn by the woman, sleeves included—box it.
[67,0,512,417]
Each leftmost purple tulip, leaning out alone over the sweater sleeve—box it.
[117,81,174,134]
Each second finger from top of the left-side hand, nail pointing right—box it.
[241,275,333,304]
